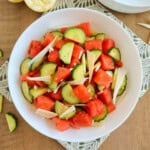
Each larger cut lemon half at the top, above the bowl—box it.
[24,0,56,12]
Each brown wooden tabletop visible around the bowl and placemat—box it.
[0,0,150,150]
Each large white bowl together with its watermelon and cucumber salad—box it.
[8,8,142,142]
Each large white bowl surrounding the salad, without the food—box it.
[8,8,142,142]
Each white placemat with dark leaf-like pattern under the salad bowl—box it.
[0,0,150,150]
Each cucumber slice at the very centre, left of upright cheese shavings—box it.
[72,64,85,80]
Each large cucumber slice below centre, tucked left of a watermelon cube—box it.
[61,84,80,104]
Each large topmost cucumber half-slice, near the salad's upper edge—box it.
[64,27,86,44]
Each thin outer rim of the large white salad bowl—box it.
[8,8,143,142]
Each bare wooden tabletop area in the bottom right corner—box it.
[100,91,150,150]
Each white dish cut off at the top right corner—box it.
[99,0,150,13]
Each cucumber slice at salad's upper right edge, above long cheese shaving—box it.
[108,48,121,61]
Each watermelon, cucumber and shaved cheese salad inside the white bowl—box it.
[20,22,127,131]
